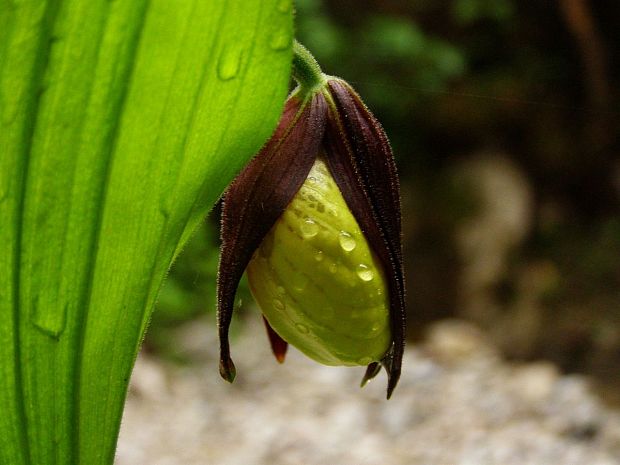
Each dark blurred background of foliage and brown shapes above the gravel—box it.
[145,0,620,405]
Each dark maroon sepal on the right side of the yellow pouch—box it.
[325,79,406,398]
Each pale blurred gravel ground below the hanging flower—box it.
[117,321,620,465]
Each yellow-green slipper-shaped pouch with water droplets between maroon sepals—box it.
[247,157,391,365]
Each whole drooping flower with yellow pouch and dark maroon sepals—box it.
[218,70,405,398]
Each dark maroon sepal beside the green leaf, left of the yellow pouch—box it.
[217,93,327,381]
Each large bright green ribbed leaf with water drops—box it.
[0,0,292,465]
